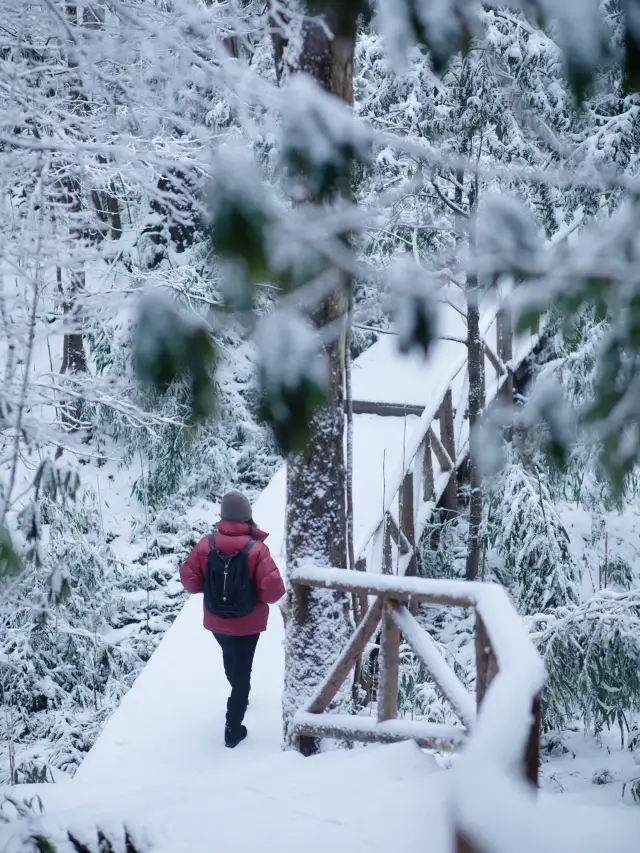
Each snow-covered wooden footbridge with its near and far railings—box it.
[51,295,564,853]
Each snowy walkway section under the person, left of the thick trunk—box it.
[74,466,284,784]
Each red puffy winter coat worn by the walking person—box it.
[180,521,285,637]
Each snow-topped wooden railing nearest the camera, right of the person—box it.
[291,566,544,853]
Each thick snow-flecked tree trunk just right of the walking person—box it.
[272,0,357,755]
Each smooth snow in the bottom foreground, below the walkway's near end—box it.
[0,740,448,853]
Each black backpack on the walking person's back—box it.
[204,533,256,619]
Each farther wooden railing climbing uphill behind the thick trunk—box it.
[353,294,538,575]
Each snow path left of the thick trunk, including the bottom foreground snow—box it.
[0,460,449,853]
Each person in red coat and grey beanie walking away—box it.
[180,492,285,748]
